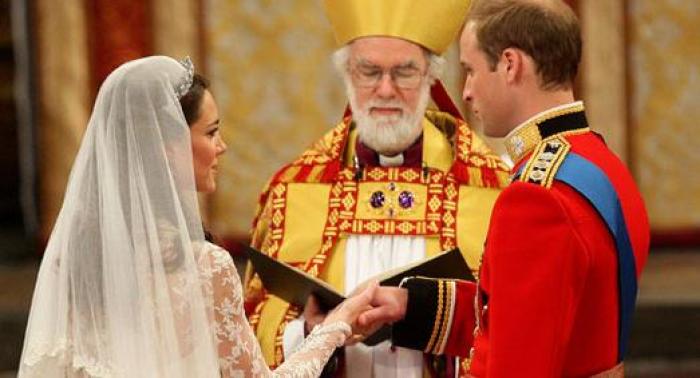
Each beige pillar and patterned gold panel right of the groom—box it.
[579,0,700,230]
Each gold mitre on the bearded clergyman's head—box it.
[323,0,469,55]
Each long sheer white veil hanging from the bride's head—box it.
[19,56,219,378]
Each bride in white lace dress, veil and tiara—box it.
[19,56,373,378]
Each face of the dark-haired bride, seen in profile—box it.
[190,90,226,193]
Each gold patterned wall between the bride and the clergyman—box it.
[205,0,344,237]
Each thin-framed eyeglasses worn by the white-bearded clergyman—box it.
[350,63,425,89]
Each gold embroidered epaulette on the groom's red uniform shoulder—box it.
[519,135,571,189]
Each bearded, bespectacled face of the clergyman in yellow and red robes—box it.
[346,37,430,155]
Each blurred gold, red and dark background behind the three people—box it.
[0,0,700,377]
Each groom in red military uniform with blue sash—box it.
[360,0,649,377]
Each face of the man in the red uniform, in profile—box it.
[459,23,510,137]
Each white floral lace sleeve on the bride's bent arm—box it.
[201,245,351,377]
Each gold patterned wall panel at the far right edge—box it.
[628,0,700,231]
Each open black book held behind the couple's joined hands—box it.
[246,247,474,346]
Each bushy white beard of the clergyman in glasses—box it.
[346,81,430,155]
